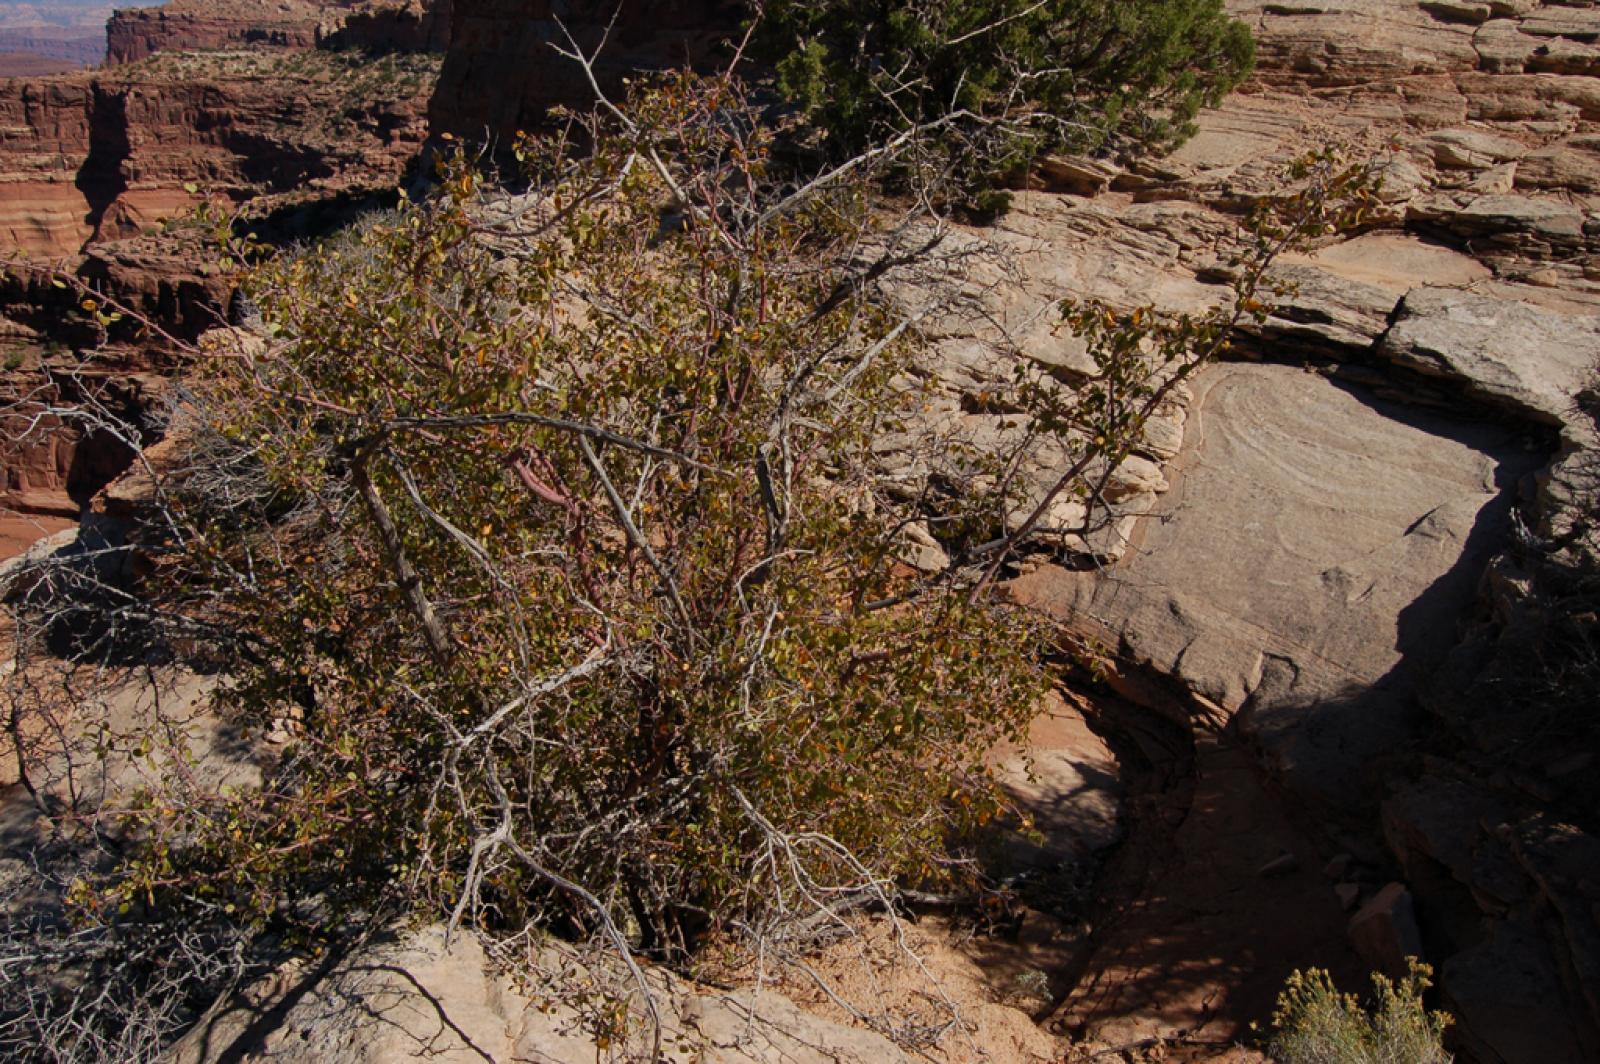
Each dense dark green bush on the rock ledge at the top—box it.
[757,0,1254,202]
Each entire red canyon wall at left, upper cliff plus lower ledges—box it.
[0,0,448,514]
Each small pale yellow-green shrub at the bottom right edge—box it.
[1270,957,1451,1064]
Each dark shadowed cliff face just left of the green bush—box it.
[429,0,742,142]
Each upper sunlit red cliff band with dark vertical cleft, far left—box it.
[0,53,435,256]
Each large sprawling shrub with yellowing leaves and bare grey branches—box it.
[103,80,1040,985]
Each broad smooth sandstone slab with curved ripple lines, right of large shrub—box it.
[1018,365,1531,808]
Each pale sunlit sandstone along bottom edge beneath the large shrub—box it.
[168,928,985,1064]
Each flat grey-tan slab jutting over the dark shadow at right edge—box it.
[1378,288,1600,426]
